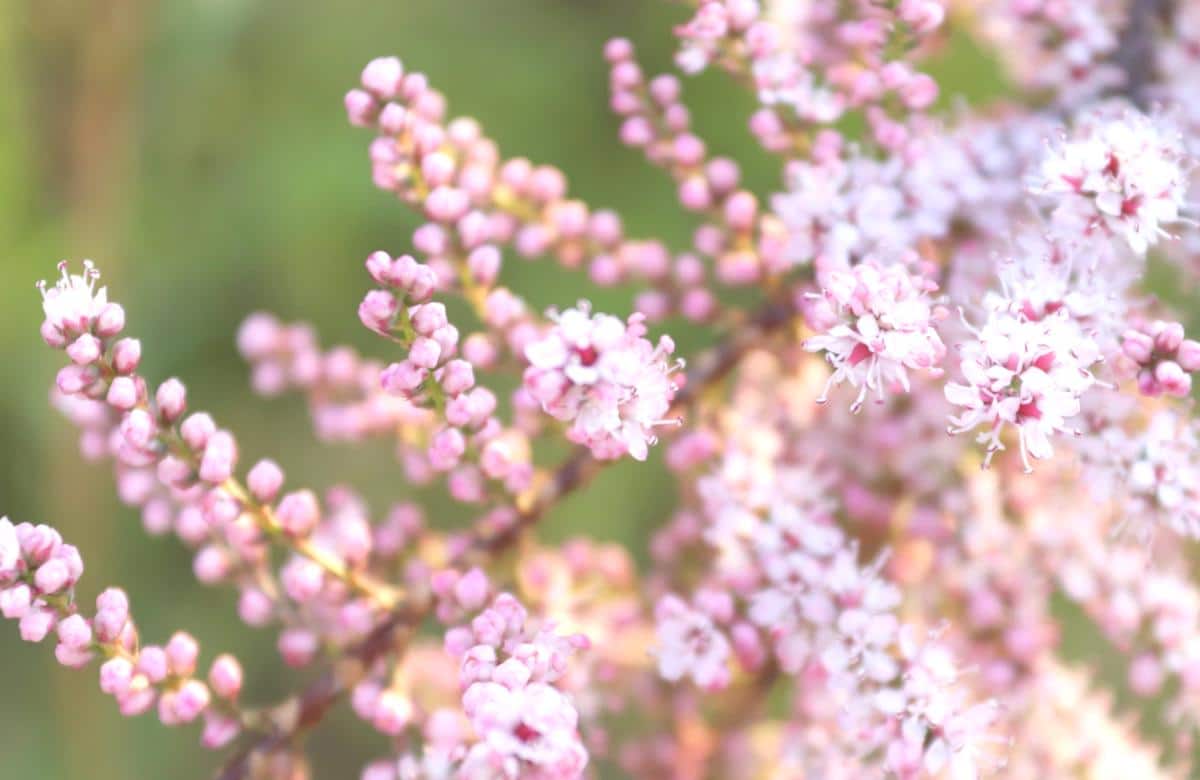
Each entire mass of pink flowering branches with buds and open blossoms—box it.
[11,0,1200,780]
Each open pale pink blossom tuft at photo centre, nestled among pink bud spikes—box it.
[524,304,679,461]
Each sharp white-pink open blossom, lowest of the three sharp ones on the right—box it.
[946,302,1100,470]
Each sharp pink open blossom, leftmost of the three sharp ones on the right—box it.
[804,262,946,409]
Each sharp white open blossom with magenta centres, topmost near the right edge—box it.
[1031,104,1188,254]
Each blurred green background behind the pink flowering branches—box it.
[0,0,998,780]
